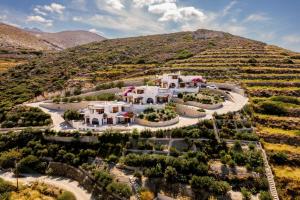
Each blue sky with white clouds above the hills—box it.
[0,0,300,52]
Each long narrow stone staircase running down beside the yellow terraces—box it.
[259,143,279,200]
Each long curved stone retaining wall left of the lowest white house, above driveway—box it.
[40,101,91,111]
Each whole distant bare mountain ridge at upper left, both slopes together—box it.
[0,22,105,51]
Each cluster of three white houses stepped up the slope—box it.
[78,73,206,129]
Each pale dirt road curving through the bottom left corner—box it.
[0,172,91,200]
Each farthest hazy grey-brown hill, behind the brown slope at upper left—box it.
[27,30,105,49]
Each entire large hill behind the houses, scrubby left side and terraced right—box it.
[0,27,300,199]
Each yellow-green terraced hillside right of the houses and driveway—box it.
[166,46,300,199]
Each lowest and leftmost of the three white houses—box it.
[82,102,134,126]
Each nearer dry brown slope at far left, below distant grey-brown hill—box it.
[0,23,57,50]
